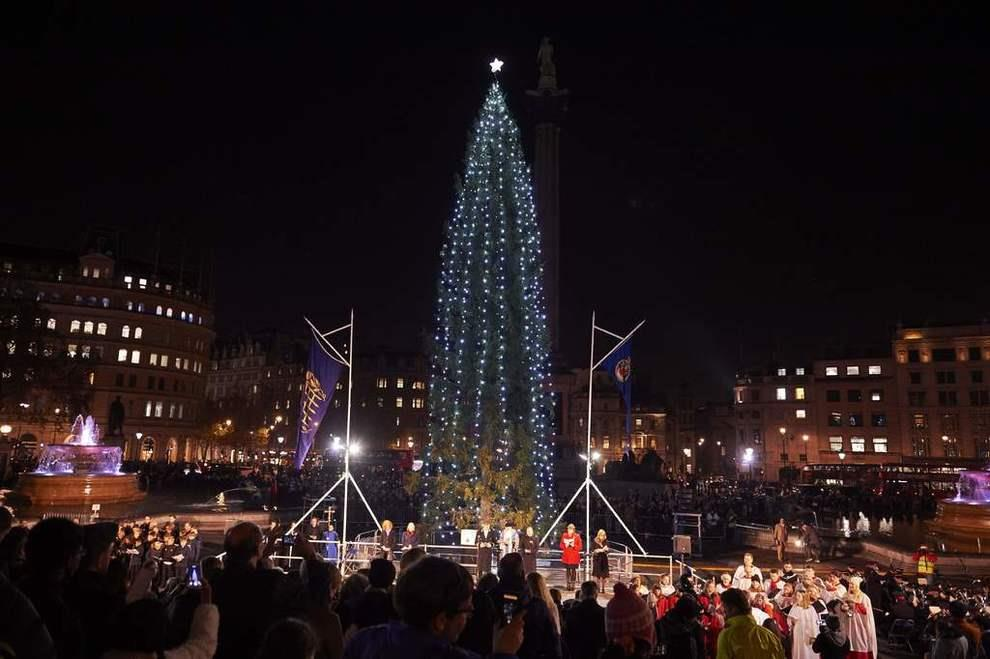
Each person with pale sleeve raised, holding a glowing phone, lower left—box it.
[102,582,219,659]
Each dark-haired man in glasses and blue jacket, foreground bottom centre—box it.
[344,556,528,659]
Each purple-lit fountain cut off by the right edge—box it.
[928,471,990,553]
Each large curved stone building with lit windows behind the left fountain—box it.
[0,240,213,461]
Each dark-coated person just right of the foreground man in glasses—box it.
[492,553,562,659]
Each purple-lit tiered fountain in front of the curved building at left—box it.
[17,415,144,506]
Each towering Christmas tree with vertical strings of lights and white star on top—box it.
[421,60,554,529]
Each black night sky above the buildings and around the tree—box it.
[0,2,990,402]
